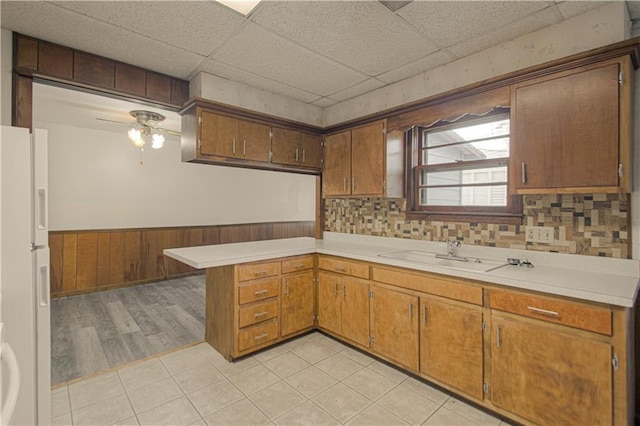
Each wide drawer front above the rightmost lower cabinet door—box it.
[490,291,611,336]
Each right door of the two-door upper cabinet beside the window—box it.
[351,122,386,196]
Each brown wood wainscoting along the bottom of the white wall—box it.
[49,221,315,297]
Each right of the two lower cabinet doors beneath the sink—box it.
[420,298,483,399]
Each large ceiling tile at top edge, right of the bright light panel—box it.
[251,1,437,76]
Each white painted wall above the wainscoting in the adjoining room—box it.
[40,121,315,230]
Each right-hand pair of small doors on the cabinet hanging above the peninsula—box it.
[271,127,322,169]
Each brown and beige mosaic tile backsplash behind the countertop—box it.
[324,194,631,259]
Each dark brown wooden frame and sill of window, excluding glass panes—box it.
[405,107,523,224]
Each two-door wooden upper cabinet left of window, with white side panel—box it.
[322,120,404,197]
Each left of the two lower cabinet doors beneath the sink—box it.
[371,285,418,370]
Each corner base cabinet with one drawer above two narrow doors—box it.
[318,256,369,347]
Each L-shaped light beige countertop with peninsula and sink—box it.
[164,232,640,307]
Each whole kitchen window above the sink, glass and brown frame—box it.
[408,108,522,223]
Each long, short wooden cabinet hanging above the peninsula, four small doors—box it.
[182,103,322,173]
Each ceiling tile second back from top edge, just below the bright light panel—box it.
[211,24,367,96]
